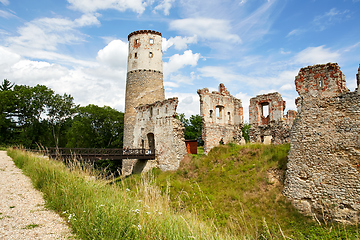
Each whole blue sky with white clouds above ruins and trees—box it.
[0,0,360,119]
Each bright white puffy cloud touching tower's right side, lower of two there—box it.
[164,50,200,79]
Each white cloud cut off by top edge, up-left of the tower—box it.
[67,0,147,14]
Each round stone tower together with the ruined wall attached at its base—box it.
[122,30,186,175]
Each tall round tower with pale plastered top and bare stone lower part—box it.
[124,30,165,147]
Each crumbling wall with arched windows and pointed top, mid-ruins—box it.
[197,83,244,153]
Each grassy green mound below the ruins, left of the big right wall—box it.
[126,144,359,239]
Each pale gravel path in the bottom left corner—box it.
[0,151,73,240]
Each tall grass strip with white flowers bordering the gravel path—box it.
[8,150,235,239]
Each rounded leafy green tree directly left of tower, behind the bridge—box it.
[66,104,124,148]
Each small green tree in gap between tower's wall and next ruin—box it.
[178,113,204,146]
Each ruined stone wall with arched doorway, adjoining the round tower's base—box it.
[123,98,186,173]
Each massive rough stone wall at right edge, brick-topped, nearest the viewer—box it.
[284,63,360,222]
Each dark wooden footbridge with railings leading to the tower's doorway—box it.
[30,148,155,162]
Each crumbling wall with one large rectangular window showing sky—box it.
[249,92,296,144]
